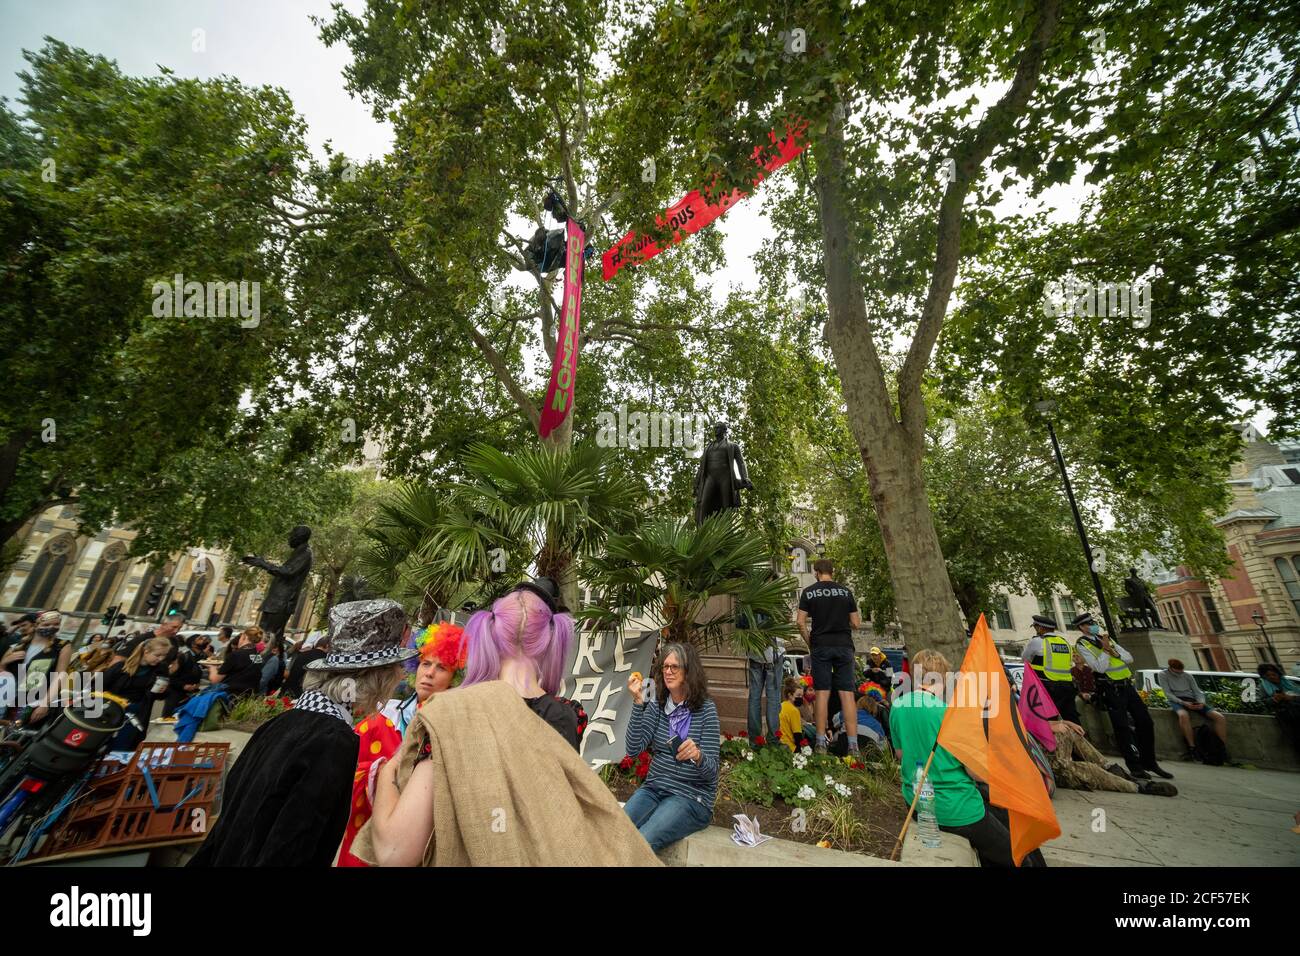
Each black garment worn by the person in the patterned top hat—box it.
[189,710,360,866]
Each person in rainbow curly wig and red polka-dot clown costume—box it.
[337,623,469,866]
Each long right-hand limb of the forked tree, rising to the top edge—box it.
[898,0,1061,438]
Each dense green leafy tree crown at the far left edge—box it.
[0,40,314,554]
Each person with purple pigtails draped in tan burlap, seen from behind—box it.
[356,578,655,866]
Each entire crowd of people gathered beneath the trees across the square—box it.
[0,559,1300,866]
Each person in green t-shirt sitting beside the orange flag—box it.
[889,650,1047,866]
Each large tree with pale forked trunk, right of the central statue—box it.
[603,0,1295,657]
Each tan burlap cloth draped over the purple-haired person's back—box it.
[352,680,662,866]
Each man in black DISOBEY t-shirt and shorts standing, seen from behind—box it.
[798,558,862,753]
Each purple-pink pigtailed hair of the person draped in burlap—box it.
[463,591,573,695]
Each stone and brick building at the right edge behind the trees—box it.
[1156,425,1300,671]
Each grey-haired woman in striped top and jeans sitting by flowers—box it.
[624,644,720,851]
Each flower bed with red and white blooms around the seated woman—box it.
[601,734,907,857]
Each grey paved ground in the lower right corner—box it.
[1043,761,1300,866]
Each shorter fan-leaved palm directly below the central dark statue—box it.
[580,511,794,652]
